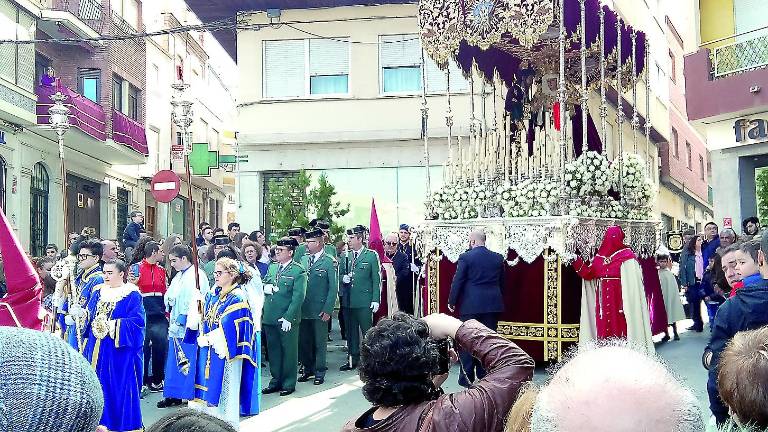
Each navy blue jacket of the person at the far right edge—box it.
[707,274,768,424]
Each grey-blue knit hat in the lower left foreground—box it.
[0,327,104,432]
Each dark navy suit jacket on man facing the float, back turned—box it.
[448,246,504,315]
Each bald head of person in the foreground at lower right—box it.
[524,340,705,432]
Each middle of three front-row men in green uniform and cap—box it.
[298,229,339,385]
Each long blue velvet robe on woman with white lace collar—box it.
[83,286,146,432]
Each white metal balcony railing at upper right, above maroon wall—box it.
[710,34,768,79]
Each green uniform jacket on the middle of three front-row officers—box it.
[301,252,339,319]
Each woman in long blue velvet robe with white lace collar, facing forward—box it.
[83,260,146,432]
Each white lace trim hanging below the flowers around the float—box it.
[415,216,660,263]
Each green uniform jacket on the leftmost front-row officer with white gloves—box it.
[262,261,307,325]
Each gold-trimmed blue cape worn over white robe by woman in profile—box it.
[185,287,261,416]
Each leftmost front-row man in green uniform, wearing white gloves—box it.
[262,237,307,396]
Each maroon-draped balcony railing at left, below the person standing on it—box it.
[36,85,107,141]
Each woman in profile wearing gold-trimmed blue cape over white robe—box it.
[187,258,260,427]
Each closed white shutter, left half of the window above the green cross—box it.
[264,40,306,98]
